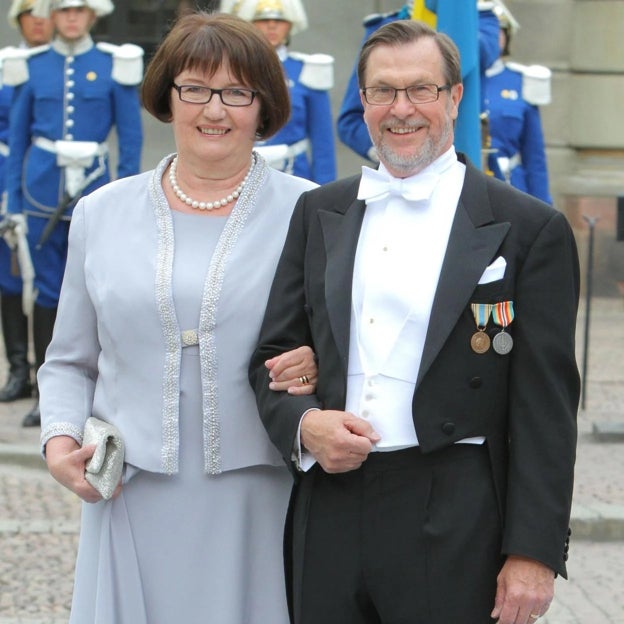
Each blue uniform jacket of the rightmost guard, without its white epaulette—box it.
[486,61,552,204]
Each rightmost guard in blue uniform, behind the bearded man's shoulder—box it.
[485,5,552,204]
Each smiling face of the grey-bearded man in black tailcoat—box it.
[361,37,463,177]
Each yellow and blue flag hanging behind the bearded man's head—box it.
[412,0,481,167]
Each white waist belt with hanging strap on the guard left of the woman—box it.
[33,137,108,197]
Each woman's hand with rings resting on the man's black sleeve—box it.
[264,347,318,395]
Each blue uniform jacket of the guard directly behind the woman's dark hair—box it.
[259,56,336,184]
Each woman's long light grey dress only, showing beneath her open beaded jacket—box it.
[71,212,291,624]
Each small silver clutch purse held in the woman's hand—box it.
[82,416,124,499]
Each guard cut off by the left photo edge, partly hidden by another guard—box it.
[0,0,53,402]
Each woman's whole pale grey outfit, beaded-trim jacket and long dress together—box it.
[39,159,310,624]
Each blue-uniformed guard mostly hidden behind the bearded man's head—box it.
[337,0,498,163]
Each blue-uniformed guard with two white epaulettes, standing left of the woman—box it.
[3,0,143,426]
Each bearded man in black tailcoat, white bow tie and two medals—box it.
[250,21,579,624]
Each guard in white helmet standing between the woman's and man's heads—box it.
[221,0,336,184]
